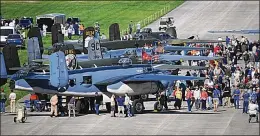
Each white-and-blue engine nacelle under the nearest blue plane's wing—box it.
[107,82,134,94]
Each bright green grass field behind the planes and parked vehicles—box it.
[1,1,183,103]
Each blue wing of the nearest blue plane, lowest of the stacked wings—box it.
[124,74,205,82]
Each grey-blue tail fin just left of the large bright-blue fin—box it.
[27,37,42,64]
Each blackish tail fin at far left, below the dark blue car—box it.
[1,46,21,75]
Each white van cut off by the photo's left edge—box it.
[0,26,17,46]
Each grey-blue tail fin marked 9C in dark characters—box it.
[88,38,102,60]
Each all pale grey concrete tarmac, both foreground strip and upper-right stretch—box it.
[1,1,259,135]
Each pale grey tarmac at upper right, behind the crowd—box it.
[146,1,260,40]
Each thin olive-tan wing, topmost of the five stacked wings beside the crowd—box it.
[168,39,225,44]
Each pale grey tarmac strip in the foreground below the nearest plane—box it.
[1,102,259,135]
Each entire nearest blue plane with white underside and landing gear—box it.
[0,51,203,113]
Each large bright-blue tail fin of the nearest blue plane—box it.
[50,51,69,88]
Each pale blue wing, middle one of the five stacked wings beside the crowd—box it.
[160,54,223,61]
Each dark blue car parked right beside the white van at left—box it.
[6,34,25,48]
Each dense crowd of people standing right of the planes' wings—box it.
[164,36,260,120]
